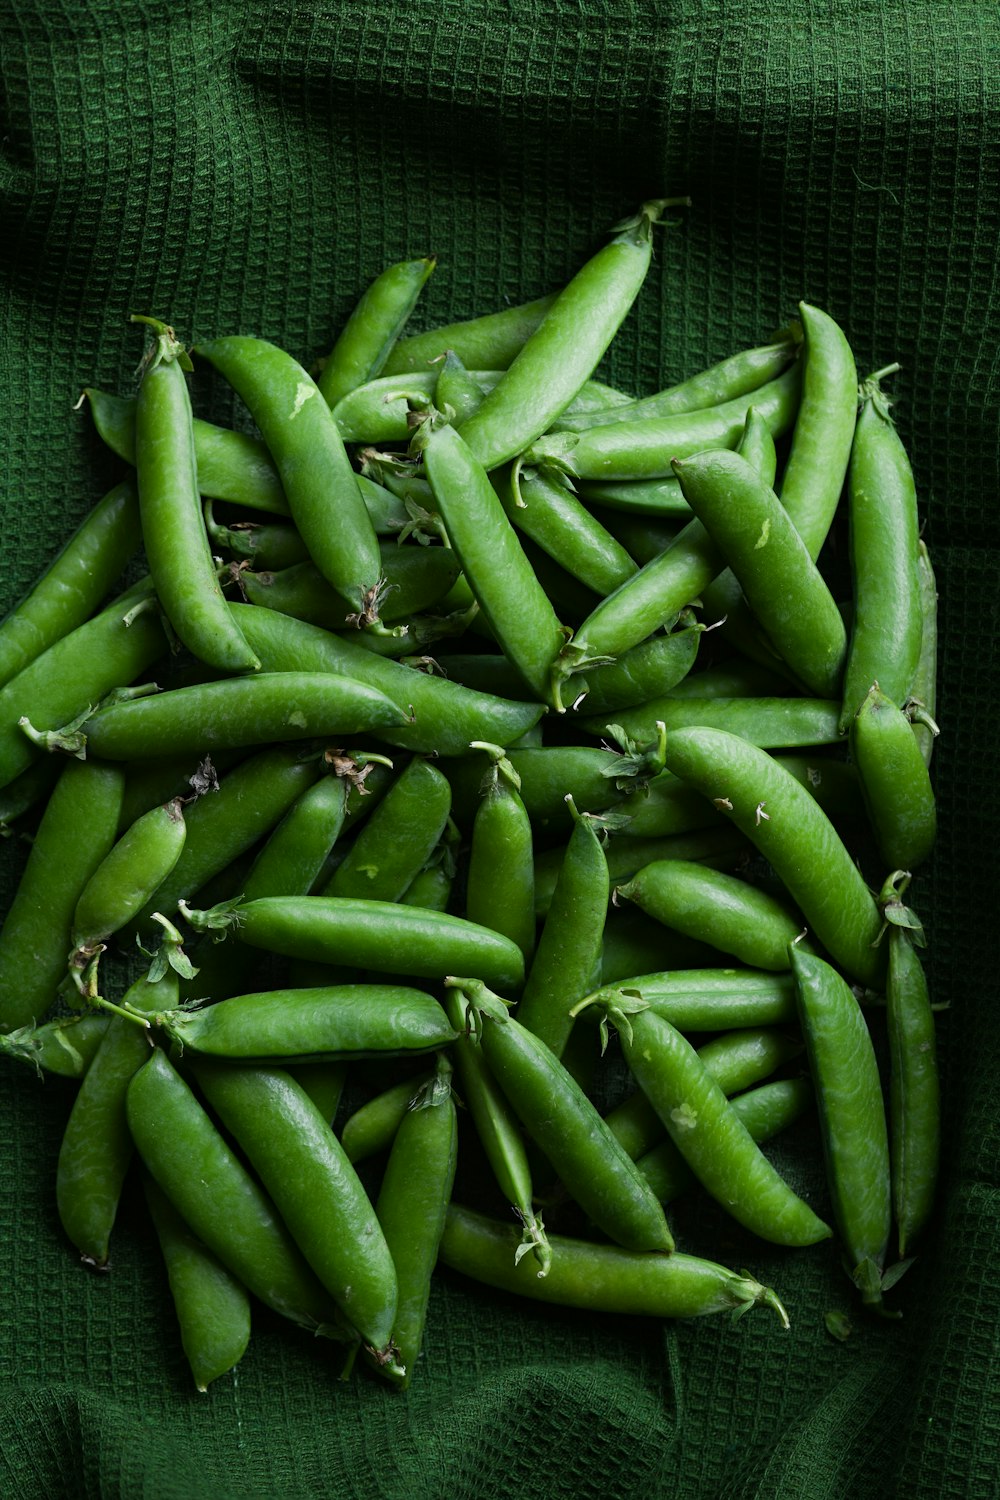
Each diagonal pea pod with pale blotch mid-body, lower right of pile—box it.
[619,1001,831,1245]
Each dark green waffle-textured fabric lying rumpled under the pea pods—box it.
[0,0,1000,1500]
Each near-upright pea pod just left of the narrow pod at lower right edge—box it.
[789,944,892,1305]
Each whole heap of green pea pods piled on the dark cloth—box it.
[0,200,939,1391]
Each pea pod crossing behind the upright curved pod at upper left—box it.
[84,387,289,516]
